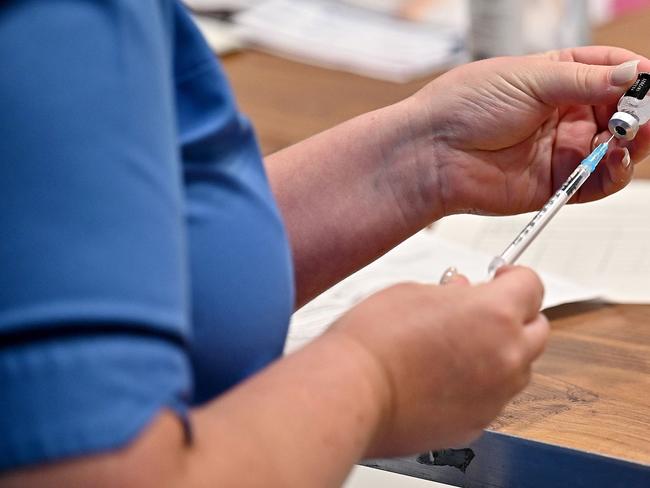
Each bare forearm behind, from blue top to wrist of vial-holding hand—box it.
[266,99,441,305]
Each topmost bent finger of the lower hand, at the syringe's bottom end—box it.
[486,266,544,322]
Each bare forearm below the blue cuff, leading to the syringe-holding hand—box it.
[0,333,388,488]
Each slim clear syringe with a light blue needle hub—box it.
[488,136,614,278]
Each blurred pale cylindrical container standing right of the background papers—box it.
[468,0,526,59]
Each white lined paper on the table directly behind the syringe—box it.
[435,181,650,303]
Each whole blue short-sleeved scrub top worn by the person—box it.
[0,0,294,471]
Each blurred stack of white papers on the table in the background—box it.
[235,0,463,81]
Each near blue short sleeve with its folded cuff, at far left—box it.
[0,0,191,470]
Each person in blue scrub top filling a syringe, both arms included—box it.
[0,0,650,488]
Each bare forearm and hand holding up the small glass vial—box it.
[266,47,650,306]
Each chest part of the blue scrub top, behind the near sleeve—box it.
[174,5,294,404]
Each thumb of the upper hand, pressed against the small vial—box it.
[529,60,639,105]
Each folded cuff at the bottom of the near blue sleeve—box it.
[0,335,191,473]
